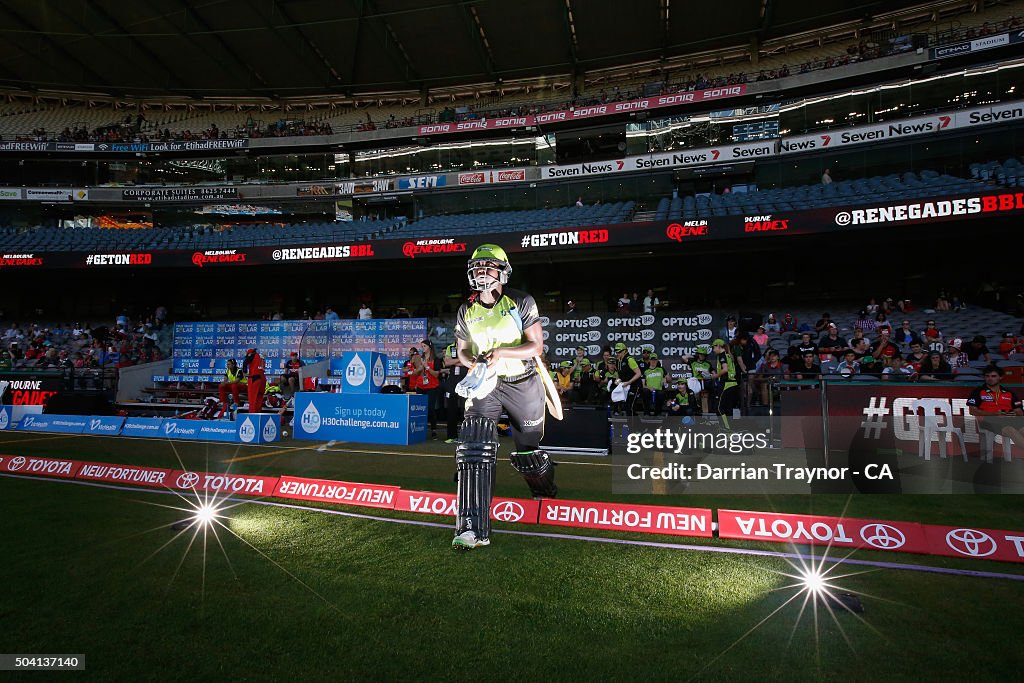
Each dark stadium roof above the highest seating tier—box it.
[0,0,948,98]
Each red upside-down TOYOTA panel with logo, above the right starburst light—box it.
[718,510,929,554]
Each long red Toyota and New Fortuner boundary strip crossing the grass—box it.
[6,455,1024,564]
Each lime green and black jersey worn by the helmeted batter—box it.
[455,289,541,377]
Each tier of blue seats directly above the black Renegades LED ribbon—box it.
[0,159,1003,252]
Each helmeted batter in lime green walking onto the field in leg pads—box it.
[452,245,558,550]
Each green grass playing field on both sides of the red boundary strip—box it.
[0,433,1024,681]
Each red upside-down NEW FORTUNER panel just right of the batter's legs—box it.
[540,499,712,539]
